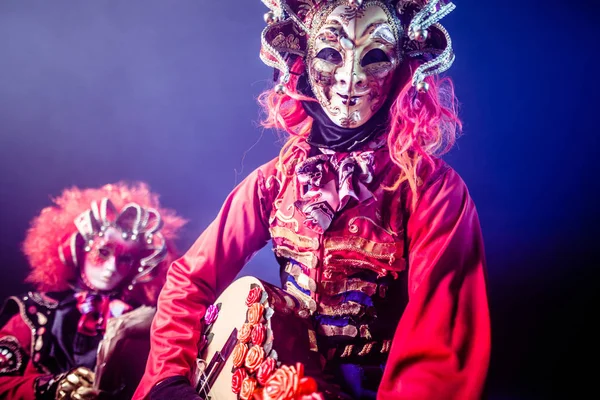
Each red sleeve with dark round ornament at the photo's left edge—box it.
[0,313,46,400]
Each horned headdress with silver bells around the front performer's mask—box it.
[260,0,455,91]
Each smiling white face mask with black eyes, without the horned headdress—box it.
[306,2,400,128]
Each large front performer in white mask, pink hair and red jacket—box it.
[134,0,490,400]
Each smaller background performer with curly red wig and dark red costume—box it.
[0,184,184,399]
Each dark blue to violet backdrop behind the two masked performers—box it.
[0,0,600,399]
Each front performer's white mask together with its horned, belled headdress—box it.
[260,0,455,119]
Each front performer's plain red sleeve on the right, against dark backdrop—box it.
[378,169,490,400]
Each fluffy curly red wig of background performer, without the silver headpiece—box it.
[23,182,187,305]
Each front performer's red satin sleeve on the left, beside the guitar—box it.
[134,160,276,399]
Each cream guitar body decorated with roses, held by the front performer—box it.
[193,277,322,400]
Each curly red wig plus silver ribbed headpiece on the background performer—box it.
[23,183,186,303]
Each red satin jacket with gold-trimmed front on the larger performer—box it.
[134,141,490,400]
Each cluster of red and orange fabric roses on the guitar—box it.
[231,286,323,400]
